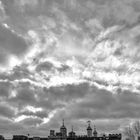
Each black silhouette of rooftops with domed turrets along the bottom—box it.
[0,119,122,140]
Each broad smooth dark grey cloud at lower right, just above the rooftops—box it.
[66,88,140,119]
